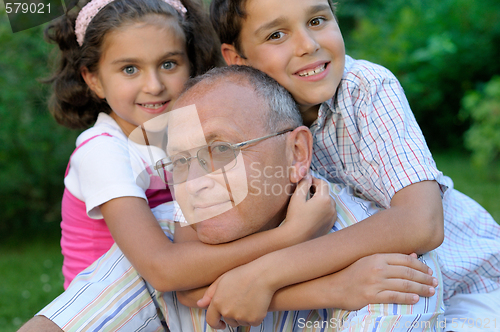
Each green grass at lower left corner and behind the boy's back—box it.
[0,153,500,332]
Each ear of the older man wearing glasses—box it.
[287,126,313,183]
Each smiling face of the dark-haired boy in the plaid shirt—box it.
[230,0,345,111]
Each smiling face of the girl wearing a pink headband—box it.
[82,17,190,136]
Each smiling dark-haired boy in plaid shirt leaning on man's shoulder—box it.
[211,0,500,331]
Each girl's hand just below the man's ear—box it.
[282,174,337,242]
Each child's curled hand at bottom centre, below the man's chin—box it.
[197,263,275,329]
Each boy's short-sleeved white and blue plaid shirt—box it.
[311,56,500,303]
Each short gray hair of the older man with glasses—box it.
[182,65,302,133]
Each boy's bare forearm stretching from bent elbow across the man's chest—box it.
[198,181,443,326]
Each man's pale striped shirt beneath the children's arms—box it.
[39,180,444,332]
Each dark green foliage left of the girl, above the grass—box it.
[0,12,80,240]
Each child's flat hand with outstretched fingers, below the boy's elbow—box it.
[325,254,438,310]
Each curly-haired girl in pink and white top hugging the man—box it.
[47,0,332,289]
